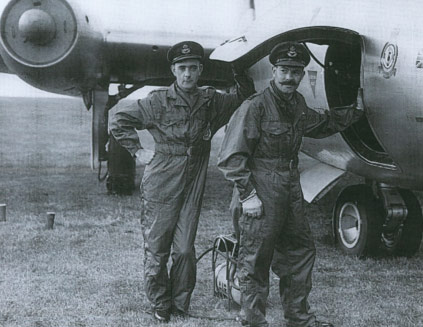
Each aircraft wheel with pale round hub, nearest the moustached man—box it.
[333,185,382,256]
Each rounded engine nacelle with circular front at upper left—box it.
[0,0,107,95]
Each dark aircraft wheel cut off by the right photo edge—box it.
[395,189,423,257]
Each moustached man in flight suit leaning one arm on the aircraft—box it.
[218,42,363,327]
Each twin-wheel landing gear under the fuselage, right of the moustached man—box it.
[333,184,423,256]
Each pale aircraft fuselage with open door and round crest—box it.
[212,1,423,190]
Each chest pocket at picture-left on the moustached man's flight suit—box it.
[260,121,291,158]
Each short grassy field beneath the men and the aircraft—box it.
[0,98,423,327]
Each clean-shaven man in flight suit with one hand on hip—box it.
[110,41,255,322]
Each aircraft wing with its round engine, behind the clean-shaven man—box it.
[0,0,238,96]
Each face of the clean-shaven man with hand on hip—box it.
[171,59,203,91]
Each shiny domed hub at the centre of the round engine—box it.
[18,9,56,45]
